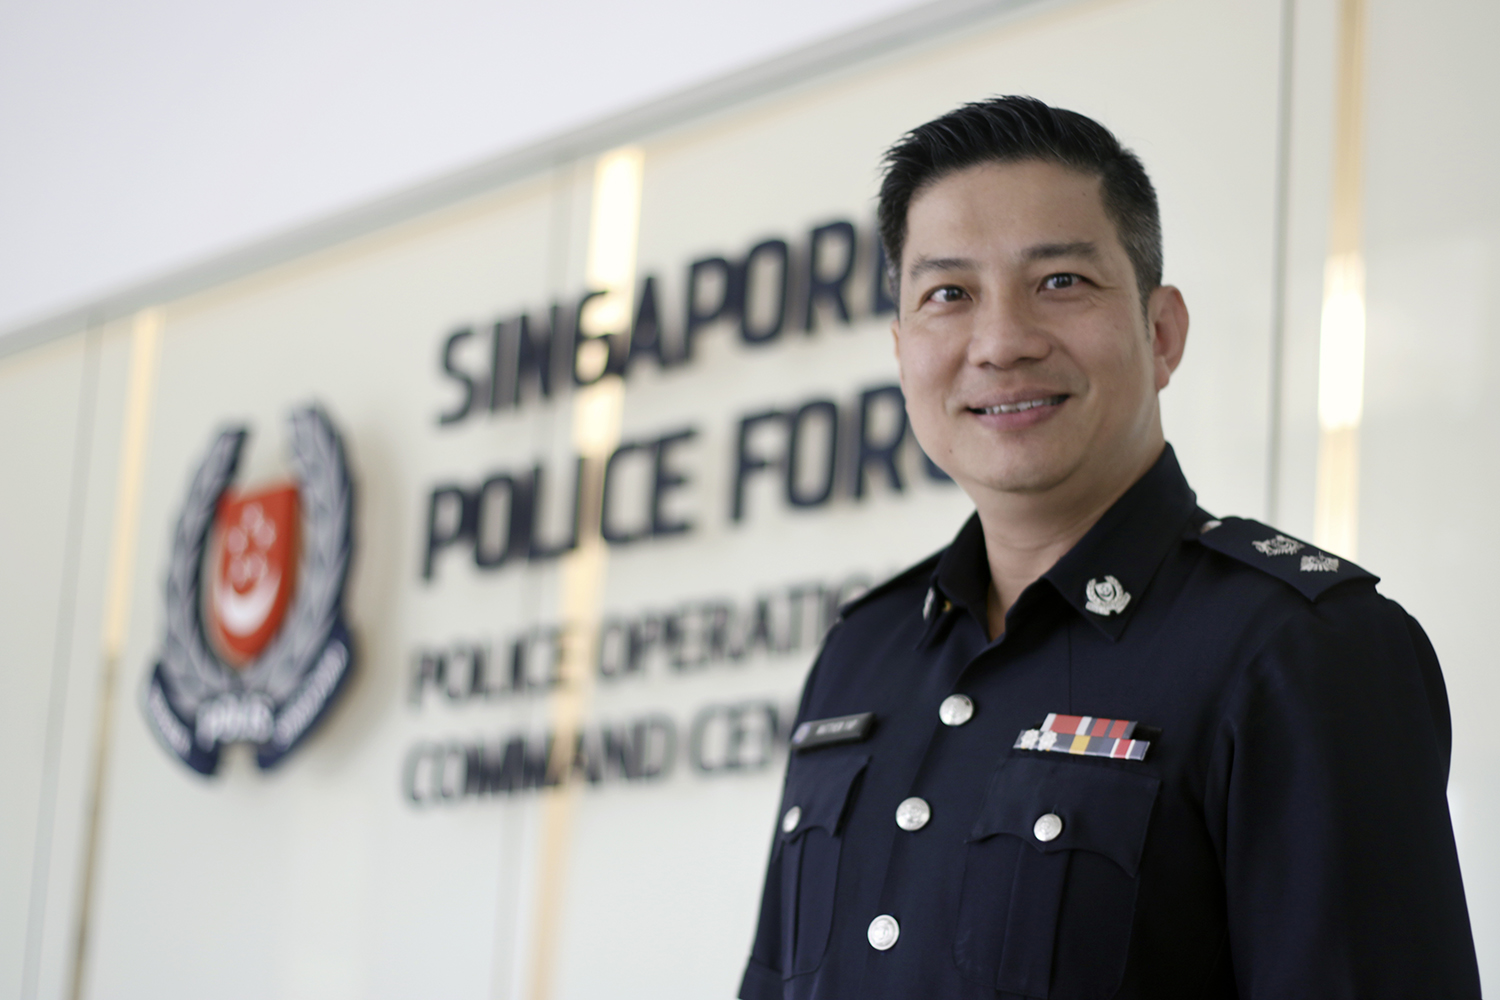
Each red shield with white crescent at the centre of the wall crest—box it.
[206,486,299,667]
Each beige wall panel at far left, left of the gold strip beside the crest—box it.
[0,316,129,997]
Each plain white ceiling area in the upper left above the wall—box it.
[0,0,921,333]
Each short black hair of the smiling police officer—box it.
[878,96,1161,307]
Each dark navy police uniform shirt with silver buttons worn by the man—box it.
[740,447,1479,1000]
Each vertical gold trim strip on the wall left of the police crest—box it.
[69,309,162,1000]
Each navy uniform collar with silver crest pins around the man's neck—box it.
[927,444,1197,639]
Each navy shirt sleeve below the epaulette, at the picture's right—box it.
[1205,585,1479,1000]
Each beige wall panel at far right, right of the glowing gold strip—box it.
[1359,0,1500,965]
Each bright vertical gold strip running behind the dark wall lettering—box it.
[530,147,644,1000]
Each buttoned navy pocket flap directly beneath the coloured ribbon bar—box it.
[969,757,1161,879]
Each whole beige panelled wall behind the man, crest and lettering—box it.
[0,0,1500,1000]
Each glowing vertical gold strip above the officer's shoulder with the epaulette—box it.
[1313,0,1367,558]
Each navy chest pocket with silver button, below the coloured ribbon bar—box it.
[954,756,1161,1000]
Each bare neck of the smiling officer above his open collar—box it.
[975,442,1164,639]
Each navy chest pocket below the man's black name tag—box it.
[776,753,870,976]
